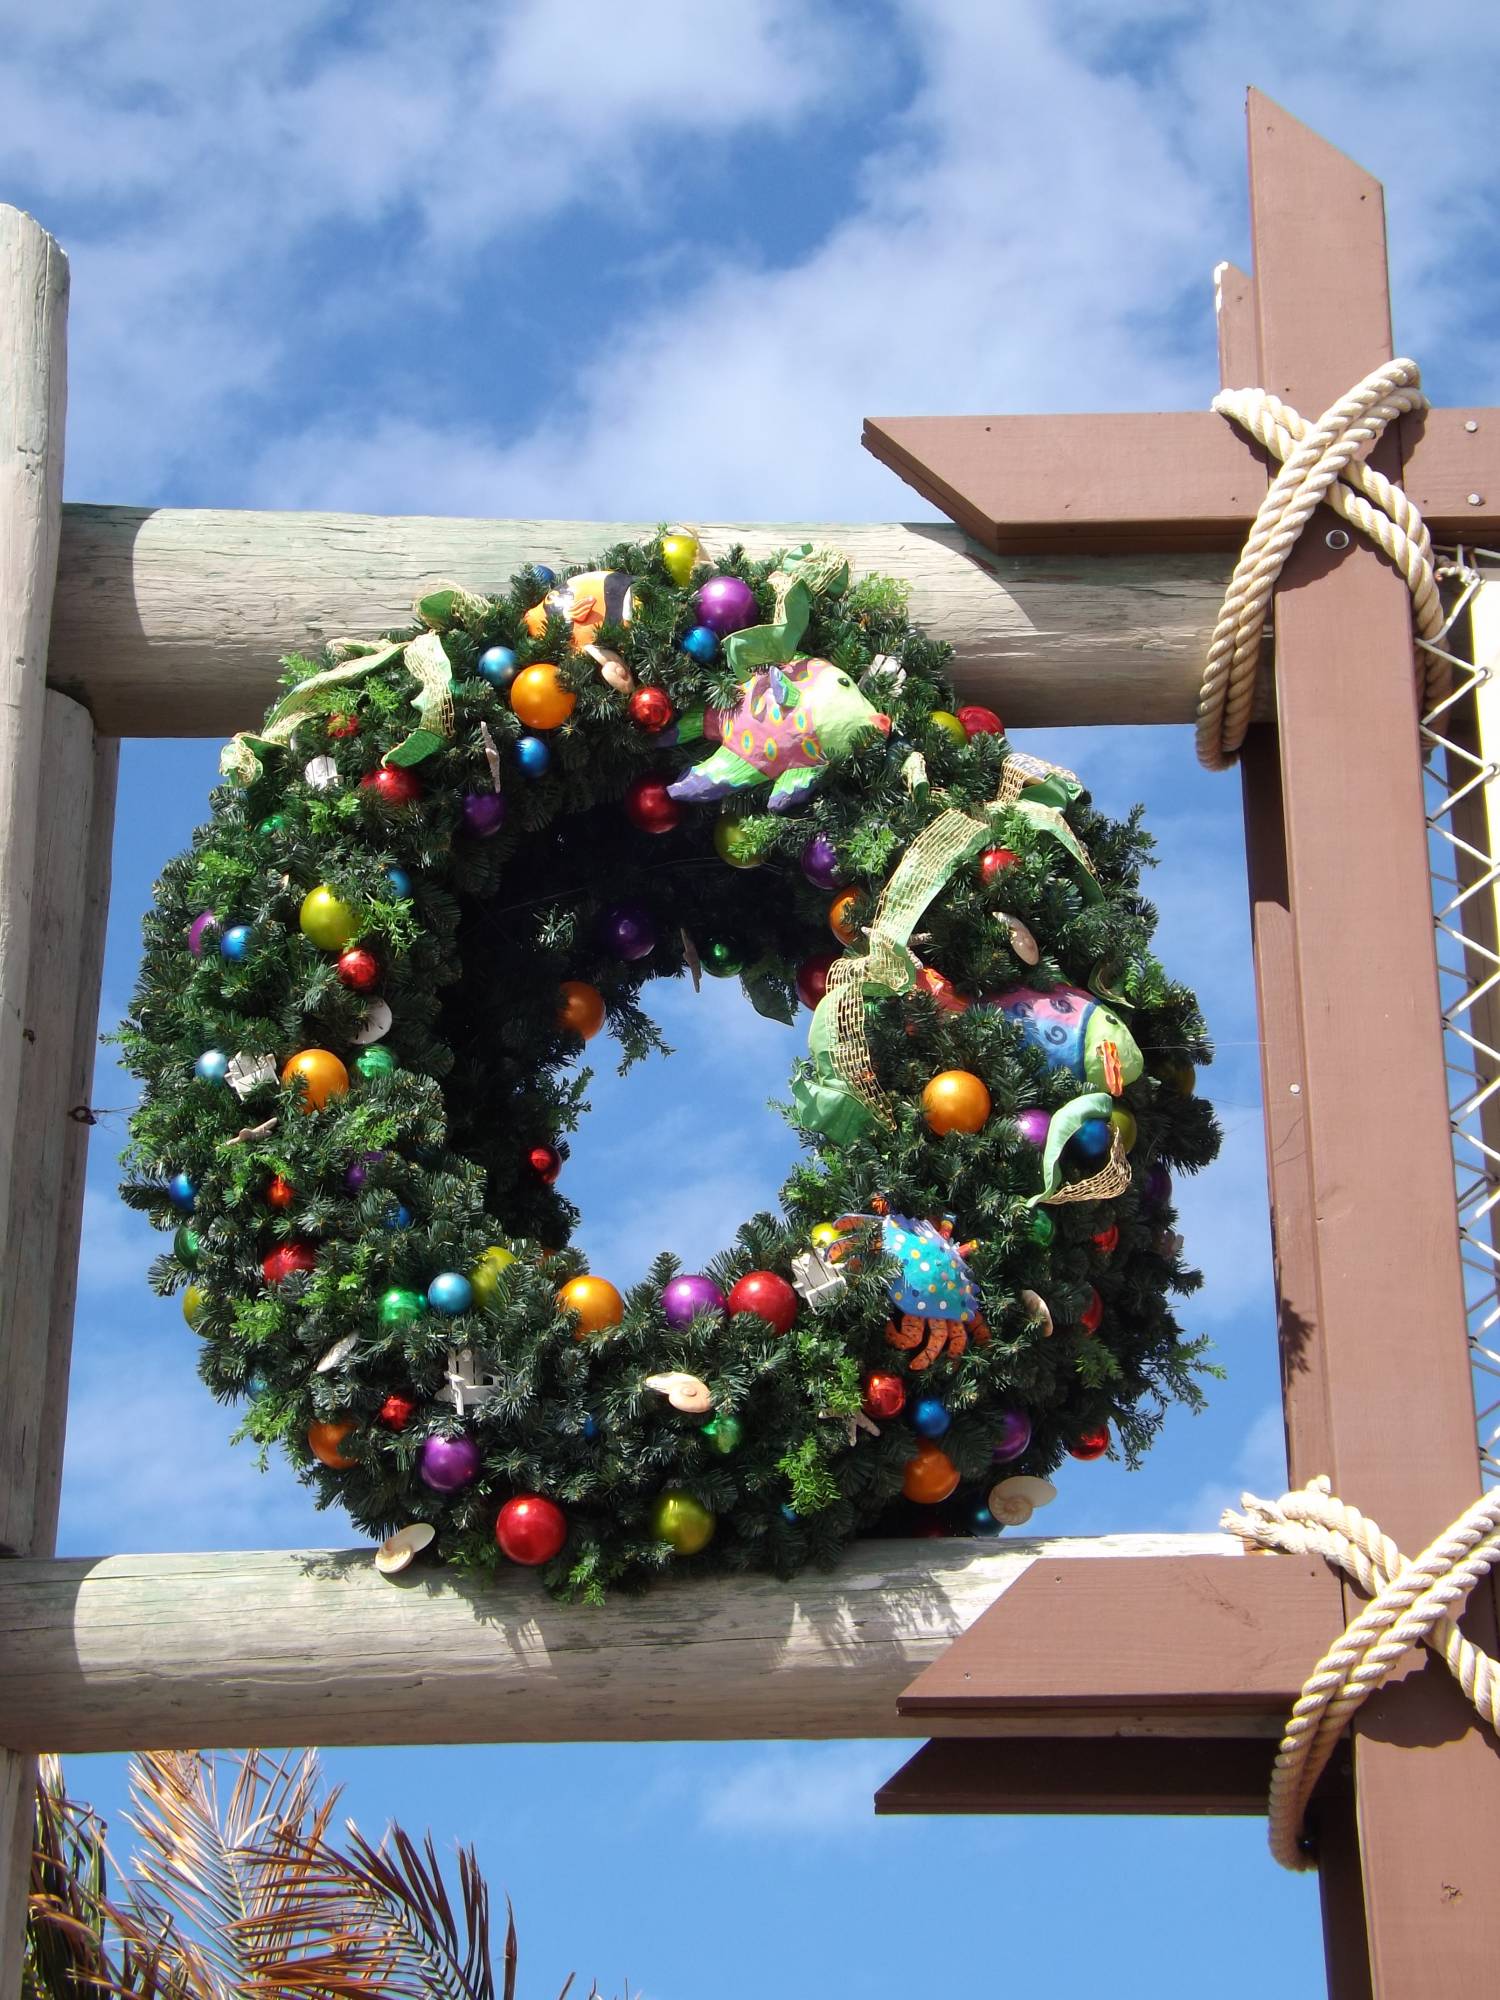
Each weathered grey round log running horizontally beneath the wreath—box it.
[0,1534,1248,1750]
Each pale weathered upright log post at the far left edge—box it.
[0,206,70,1994]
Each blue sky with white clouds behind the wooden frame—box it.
[0,0,1500,2000]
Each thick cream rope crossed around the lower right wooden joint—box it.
[1220,1478,1500,1868]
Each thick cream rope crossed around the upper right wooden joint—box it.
[1198,360,1442,770]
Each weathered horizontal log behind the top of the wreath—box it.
[48,506,1228,736]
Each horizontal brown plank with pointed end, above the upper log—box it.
[864,408,1500,556]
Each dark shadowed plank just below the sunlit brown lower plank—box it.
[876,1736,1276,1816]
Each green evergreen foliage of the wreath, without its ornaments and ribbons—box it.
[122,544,1218,1598]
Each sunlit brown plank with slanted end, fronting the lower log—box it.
[896,1556,1344,1728]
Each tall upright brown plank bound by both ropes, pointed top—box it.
[1250,92,1500,2000]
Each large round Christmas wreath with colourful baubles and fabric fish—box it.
[122,532,1216,1598]
